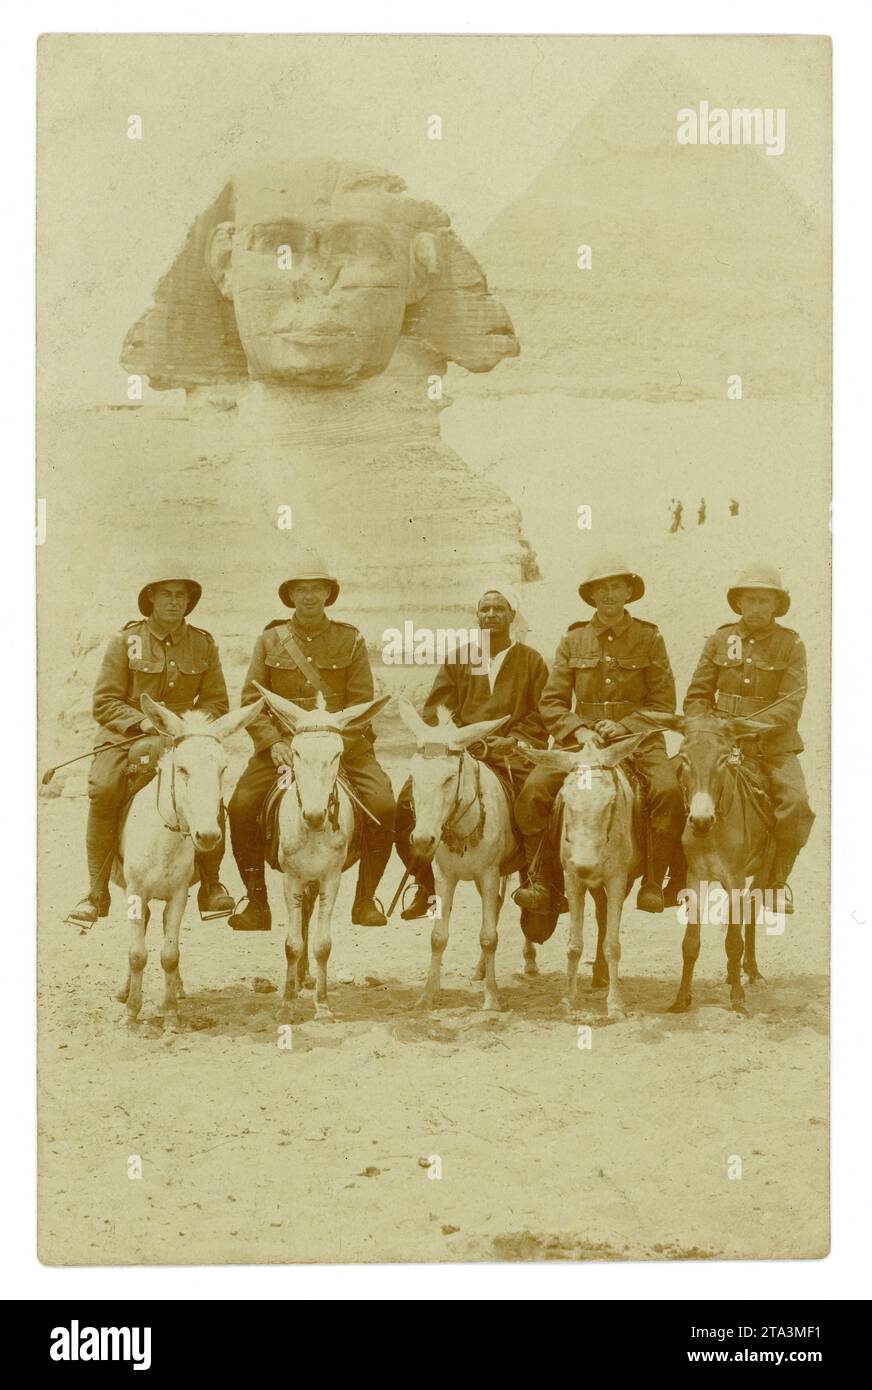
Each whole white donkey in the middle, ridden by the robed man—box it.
[399,699,515,1009]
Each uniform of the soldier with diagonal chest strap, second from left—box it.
[228,616,395,917]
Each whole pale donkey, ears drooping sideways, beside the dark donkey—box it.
[528,733,648,1020]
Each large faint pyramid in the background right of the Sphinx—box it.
[465,44,830,400]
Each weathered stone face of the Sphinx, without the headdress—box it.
[210,196,419,386]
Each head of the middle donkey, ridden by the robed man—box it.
[399,699,509,860]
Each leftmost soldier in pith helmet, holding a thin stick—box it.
[67,559,234,927]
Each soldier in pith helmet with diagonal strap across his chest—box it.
[228,550,395,931]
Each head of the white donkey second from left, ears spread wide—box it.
[255,682,391,830]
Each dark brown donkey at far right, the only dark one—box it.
[643,710,773,1013]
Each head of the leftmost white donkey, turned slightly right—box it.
[139,695,263,851]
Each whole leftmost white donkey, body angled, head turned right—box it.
[113,695,263,1026]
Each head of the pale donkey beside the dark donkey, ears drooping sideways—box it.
[527,731,648,877]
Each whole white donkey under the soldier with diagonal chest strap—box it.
[255,682,391,1023]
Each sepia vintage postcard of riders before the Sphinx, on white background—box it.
[38,35,832,1265]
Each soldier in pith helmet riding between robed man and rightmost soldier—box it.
[515,556,684,912]
